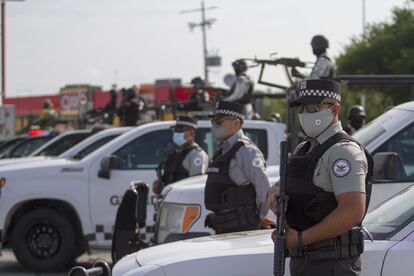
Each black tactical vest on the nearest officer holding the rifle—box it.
[286,131,373,231]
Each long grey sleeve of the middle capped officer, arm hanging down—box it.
[236,146,270,217]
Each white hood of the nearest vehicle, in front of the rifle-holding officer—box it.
[129,229,398,276]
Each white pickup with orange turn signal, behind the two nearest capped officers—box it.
[154,102,414,244]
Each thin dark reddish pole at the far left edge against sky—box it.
[0,0,24,106]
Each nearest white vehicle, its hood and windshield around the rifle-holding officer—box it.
[112,183,414,276]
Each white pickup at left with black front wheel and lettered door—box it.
[0,121,284,271]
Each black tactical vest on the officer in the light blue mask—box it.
[162,145,200,185]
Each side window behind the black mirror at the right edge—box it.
[374,124,414,181]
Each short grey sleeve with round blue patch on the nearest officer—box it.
[328,141,368,195]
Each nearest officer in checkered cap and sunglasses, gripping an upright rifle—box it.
[267,80,372,276]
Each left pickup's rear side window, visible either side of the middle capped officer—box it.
[196,128,268,159]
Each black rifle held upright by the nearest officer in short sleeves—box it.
[273,141,288,276]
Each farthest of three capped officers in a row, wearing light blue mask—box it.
[152,116,209,194]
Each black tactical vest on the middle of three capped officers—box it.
[204,141,259,234]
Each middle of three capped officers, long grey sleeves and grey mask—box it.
[204,101,271,234]
